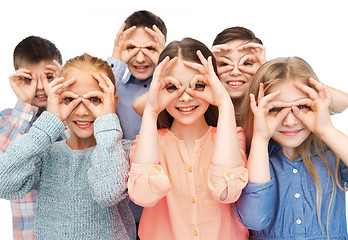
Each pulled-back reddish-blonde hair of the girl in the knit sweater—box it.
[60,53,116,89]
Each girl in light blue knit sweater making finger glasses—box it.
[0,54,135,239]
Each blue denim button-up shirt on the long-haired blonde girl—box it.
[235,142,348,240]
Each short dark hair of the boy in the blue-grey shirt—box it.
[125,10,167,39]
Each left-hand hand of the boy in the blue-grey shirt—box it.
[112,23,139,64]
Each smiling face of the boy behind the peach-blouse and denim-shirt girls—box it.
[215,40,253,99]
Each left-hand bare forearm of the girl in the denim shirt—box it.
[247,135,271,183]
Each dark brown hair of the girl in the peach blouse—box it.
[157,38,218,129]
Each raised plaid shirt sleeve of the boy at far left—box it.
[0,101,38,153]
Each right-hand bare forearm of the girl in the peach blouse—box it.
[212,102,242,168]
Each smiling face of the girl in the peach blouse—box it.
[165,59,209,126]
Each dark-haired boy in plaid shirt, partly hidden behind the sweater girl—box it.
[0,36,65,240]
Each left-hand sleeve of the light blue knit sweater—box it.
[0,112,64,199]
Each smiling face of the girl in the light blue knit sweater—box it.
[64,69,102,149]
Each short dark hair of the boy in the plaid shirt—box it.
[13,36,63,70]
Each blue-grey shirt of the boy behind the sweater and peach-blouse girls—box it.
[107,57,152,222]
